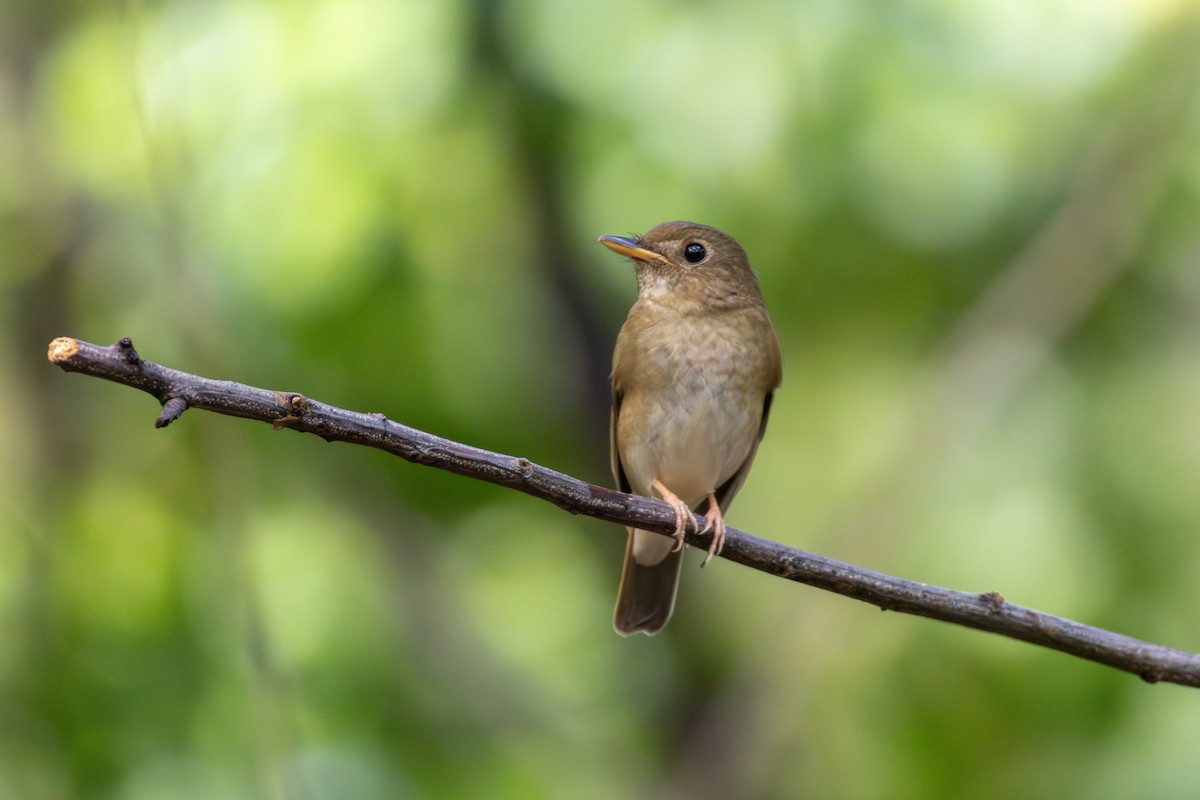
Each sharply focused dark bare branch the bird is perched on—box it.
[49,338,1200,687]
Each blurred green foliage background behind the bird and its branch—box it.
[0,0,1200,800]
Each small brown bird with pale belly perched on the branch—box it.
[599,222,782,636]
